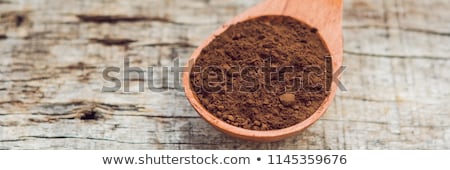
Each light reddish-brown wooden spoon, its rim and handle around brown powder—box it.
[183,0,343,141]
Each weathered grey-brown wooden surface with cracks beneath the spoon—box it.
[0,0,450,149]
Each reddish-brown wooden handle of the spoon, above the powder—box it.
[246,0,343,63]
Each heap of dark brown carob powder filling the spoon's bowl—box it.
[190,16,332,130]
